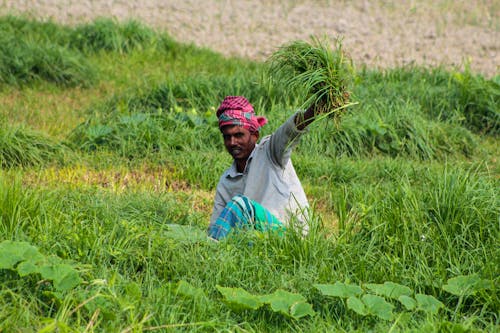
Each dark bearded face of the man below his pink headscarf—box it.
[221,126,259,161]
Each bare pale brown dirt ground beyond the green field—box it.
[0,0,500,77]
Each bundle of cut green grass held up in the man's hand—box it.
[268,37,354,119]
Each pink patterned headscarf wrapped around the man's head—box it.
[217,96,267,132]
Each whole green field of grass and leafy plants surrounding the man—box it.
[0,17,500,332]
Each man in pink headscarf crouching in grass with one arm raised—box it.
[208,96,315,239]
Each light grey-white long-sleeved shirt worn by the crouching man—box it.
[210,114,309,231]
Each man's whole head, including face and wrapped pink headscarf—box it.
[217,96,267,163]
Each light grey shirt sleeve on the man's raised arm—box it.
[269,111,307,168]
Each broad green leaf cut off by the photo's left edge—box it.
[0,240,43,269]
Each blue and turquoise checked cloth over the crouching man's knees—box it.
[208,195,284,239]
